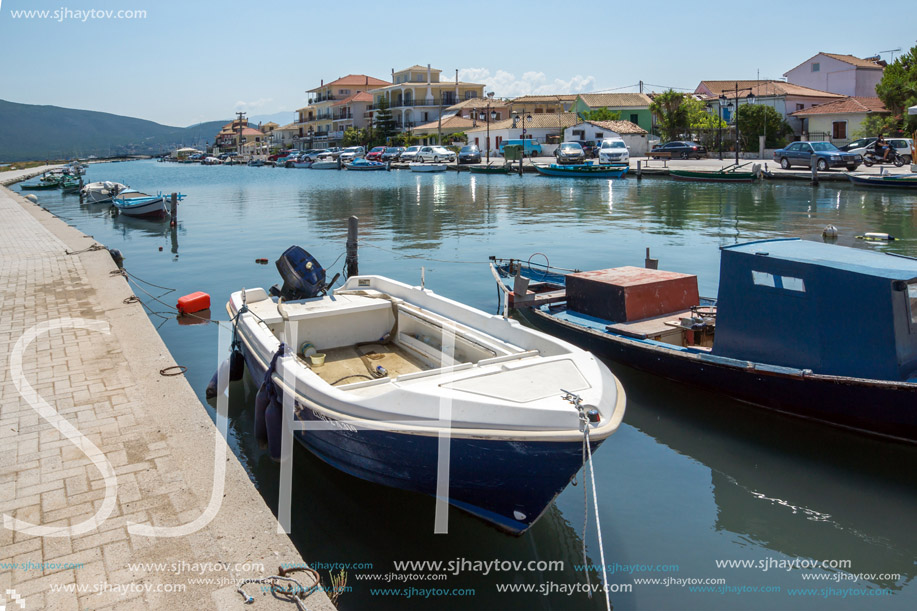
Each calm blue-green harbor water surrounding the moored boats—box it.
[21,162,917,610]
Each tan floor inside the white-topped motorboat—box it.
[302,343,429,386]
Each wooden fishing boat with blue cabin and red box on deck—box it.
[492,239,917,442]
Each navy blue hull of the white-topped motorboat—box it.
[242,335,604,535]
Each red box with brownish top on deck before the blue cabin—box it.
[566,267,700,322]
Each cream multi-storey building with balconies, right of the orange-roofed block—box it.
[370,64,484,131]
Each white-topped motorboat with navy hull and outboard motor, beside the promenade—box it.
[227,247,625,534]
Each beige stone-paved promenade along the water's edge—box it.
[0,173,334,611]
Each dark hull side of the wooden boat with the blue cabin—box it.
[516,308,917,442]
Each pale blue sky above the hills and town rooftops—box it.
[0,0,917,125]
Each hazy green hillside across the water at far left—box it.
[0,100,229,161]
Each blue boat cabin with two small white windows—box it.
[713,239,917,381]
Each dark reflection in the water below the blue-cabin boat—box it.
[618,367,917,590]
